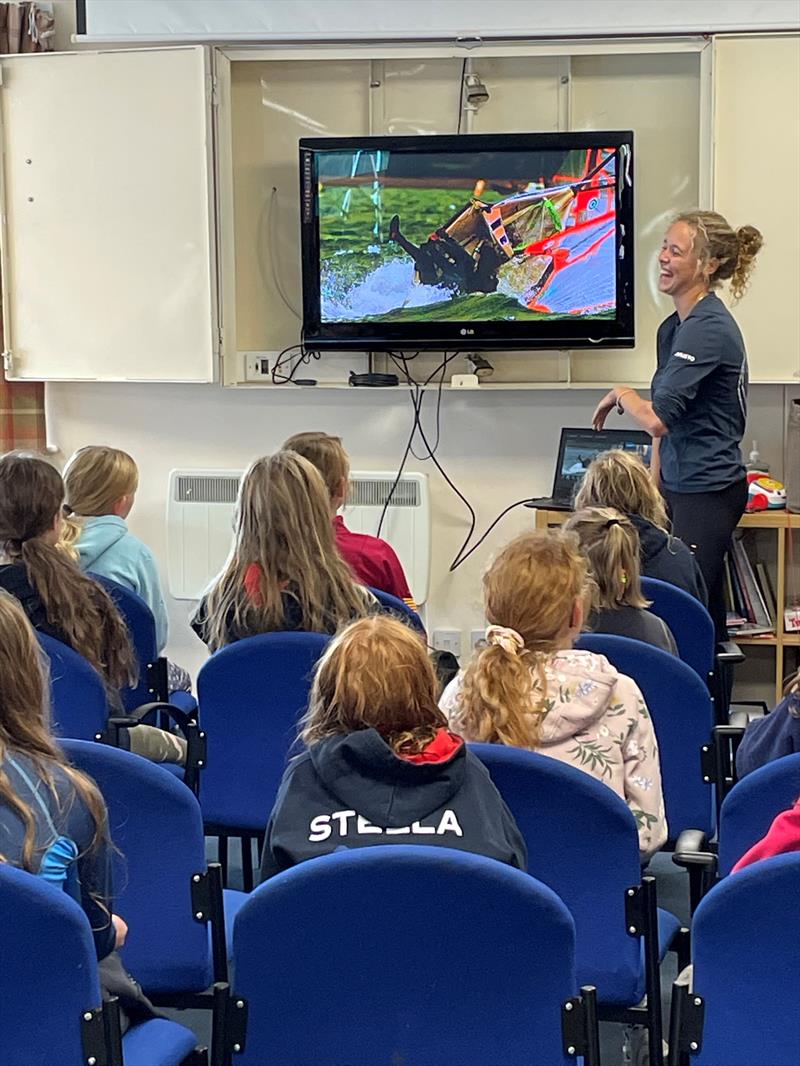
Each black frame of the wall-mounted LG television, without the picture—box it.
[300,130,636,352]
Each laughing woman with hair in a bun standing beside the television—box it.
[592,211,762,641]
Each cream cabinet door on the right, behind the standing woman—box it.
[714,34,800,383]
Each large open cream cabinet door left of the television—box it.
[0,47,219,382]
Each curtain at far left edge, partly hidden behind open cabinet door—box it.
[0,3,53,452]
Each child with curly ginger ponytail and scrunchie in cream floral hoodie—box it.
[439,532,667,857]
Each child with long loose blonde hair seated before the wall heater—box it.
[197,451,375,651]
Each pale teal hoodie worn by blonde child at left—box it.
[77,515,169,653]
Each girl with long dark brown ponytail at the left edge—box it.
[0,452,186,763]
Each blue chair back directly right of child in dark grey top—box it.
[641,578,745,725]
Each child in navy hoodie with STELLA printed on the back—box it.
[261,615,527,881]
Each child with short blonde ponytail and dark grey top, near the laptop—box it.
[564,507,677,656]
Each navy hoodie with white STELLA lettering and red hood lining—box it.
[261,729,528,881]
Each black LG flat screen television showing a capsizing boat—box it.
[300,130,634,351]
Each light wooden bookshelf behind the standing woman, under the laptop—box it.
[535,510,800,702]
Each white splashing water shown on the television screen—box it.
[321,258,452,322]
